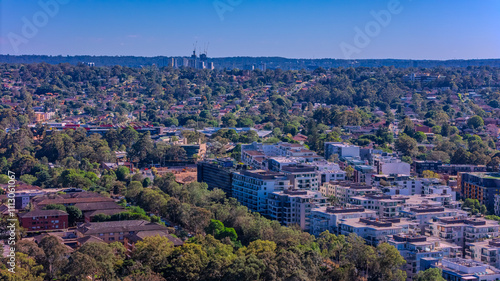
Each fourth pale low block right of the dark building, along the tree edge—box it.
[339,217,416,246]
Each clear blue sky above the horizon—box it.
[0,0,500,59]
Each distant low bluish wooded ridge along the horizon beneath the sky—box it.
[0,55,500,70]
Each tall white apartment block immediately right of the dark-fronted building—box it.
[233,170,291,215]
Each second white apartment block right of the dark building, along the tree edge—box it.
[267,190,328,231]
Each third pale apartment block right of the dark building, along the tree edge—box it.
[309,207,377,236]
